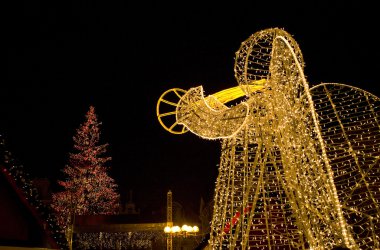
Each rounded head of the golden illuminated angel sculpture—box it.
[234,28,304,96]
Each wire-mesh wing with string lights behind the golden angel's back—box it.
[310,83,380,249]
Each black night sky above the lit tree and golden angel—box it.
[5,0,380,214]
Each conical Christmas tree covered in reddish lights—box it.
[52,106,119,233]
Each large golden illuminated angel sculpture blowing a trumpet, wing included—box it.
[157,28,380,249]
